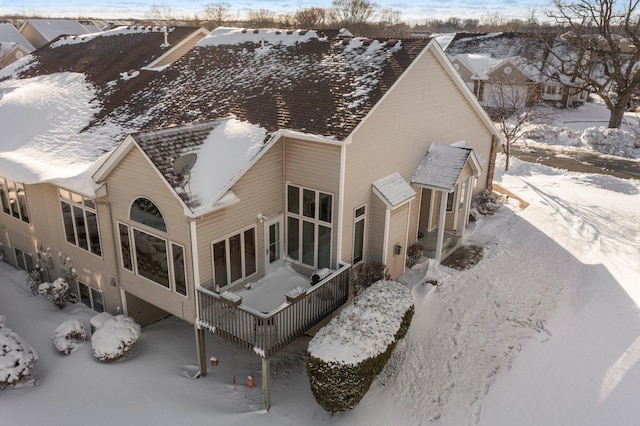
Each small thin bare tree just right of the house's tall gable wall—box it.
[484,78,542,170]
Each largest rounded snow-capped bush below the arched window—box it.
[91,315,141,361]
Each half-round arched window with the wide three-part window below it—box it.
[118,197,187,296]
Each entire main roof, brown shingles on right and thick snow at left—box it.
[0,27,428,198]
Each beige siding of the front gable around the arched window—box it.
[106,148,195,322]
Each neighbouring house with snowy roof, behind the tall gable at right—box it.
[446,33,589,107]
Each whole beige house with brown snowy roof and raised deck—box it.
[0,27,501,408]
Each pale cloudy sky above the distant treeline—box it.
[0,0,551,23]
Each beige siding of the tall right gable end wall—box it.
[343,47,492,259]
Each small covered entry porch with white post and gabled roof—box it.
[411,143,481,262]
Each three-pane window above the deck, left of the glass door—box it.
[213,228,257,288]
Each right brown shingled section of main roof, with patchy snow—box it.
[104,31,428,139]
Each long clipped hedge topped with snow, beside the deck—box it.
[307,281,414,413]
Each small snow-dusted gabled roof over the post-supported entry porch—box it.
[411,143,480,192]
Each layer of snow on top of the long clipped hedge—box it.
[309,281,413,364]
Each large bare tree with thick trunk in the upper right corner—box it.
[541,0,640,128]
